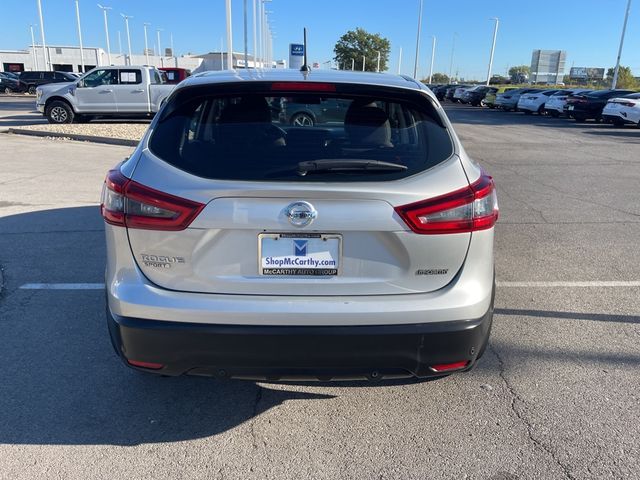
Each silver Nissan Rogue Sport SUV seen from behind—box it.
[101,70,498,379]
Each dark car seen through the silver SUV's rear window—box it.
[279,97,351,127]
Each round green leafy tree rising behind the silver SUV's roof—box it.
[333,28,391,72]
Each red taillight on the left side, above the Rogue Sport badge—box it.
[100,170,204,230]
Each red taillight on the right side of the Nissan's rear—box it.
[395,174,498,235]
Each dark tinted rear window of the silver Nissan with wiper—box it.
[149,85,453,182]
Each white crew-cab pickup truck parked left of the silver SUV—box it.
[36,66,175,123]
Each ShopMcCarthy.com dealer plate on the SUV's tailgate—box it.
[258,233,342,277]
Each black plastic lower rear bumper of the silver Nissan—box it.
[107,302,493,380]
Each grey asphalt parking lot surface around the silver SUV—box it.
[0,97,640,480]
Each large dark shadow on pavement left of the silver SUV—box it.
[0,206,332,445]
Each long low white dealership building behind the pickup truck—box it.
[0,45,202,72]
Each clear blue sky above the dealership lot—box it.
[0,0,640,79]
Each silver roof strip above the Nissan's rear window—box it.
[178,68,433,96]
